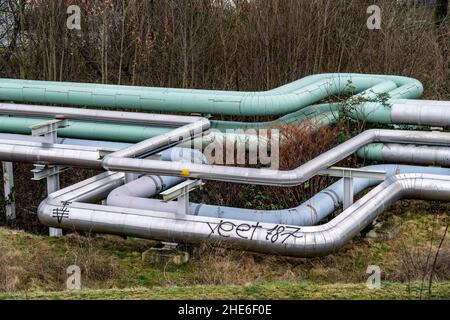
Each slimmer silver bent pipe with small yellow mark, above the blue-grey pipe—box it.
[103,129,450,186]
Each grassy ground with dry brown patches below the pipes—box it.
[0,201,450,299]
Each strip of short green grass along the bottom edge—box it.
[0,282,450,300]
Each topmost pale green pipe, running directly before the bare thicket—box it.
[0,73,423,116]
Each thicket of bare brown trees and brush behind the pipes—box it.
[0,0,450,100]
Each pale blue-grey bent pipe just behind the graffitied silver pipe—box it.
[107,164,450,226]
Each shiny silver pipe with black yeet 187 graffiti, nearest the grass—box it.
[38,174,450,257]
